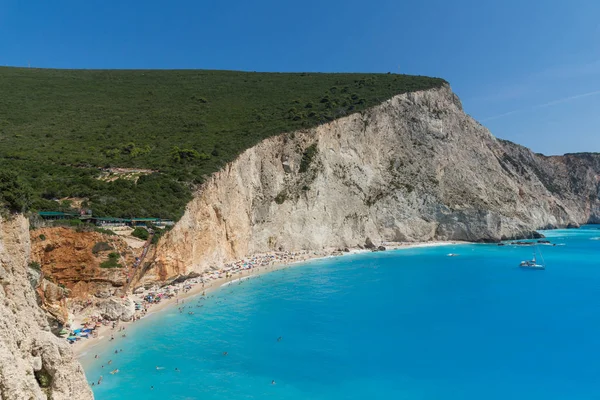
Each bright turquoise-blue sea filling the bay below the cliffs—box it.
[82,226,600,400]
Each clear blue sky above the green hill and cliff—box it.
[0,0,600,154]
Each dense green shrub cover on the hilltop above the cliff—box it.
[0,68,444,219]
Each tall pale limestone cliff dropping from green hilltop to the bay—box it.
[147,86,600,280]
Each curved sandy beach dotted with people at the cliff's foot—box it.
[71,241,465,357]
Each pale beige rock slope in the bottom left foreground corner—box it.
[0,216,93,400]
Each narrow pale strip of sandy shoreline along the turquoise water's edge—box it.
[71,241,462,358]
